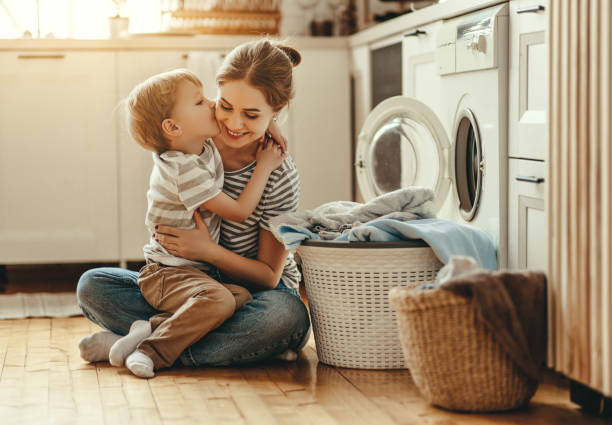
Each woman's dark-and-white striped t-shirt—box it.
[220,156,300,289]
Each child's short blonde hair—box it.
[126,69,202,154]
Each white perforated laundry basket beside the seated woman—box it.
[298,240,442,369]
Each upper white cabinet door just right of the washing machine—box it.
[508,0,548,160]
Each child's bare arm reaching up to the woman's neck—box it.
[202,143,285,222]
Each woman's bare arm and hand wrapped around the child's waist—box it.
[155,213,288,290]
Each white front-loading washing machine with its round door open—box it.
[355,3,508,268]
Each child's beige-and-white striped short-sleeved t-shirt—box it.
[143,140,223,270]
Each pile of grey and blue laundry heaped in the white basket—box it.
[271,187,497,270]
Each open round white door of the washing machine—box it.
[355,96,451,211]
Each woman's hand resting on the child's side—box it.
[153,210,218,261]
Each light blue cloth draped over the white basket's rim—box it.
[279,218,497,270]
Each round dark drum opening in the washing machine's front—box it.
[453,109,484,221]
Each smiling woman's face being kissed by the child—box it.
[216,80,275,148]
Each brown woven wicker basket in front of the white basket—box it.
[390,288,537,411]
